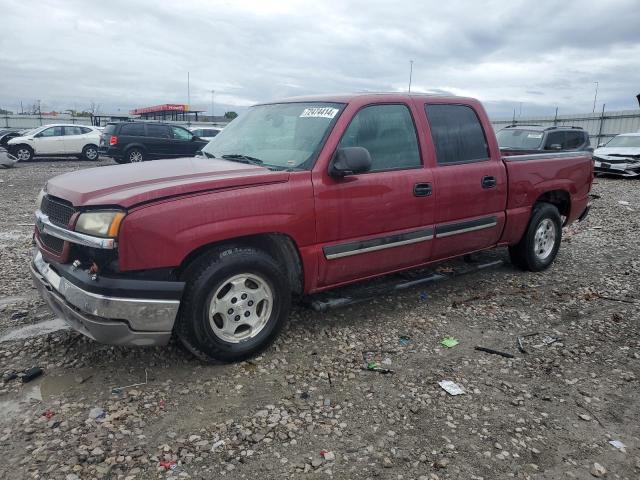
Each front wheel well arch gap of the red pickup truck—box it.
[177,233,304,294]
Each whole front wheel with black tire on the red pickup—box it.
[174,248,291,362]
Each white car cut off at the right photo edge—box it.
[593,133,640,177]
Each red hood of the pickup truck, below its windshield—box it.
[45,157,289,208]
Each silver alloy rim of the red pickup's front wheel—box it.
[207,273,273,343]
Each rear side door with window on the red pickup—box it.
[424,103,507,259]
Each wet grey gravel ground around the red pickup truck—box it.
[0,160,640,480]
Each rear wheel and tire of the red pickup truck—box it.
[509,203,562,272]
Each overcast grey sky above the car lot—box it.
[0,0,640,117]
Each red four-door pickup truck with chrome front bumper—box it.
[31,94,593,361]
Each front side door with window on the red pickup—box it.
[313,104,434,286]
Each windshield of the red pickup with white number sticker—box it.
[202,102,344,170]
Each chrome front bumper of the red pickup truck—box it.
[31,252,180,345]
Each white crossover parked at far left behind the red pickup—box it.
[7,124,100,161]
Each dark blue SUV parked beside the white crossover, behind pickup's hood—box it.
[100,122,208,163]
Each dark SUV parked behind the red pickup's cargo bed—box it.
[496,125,593,156]
